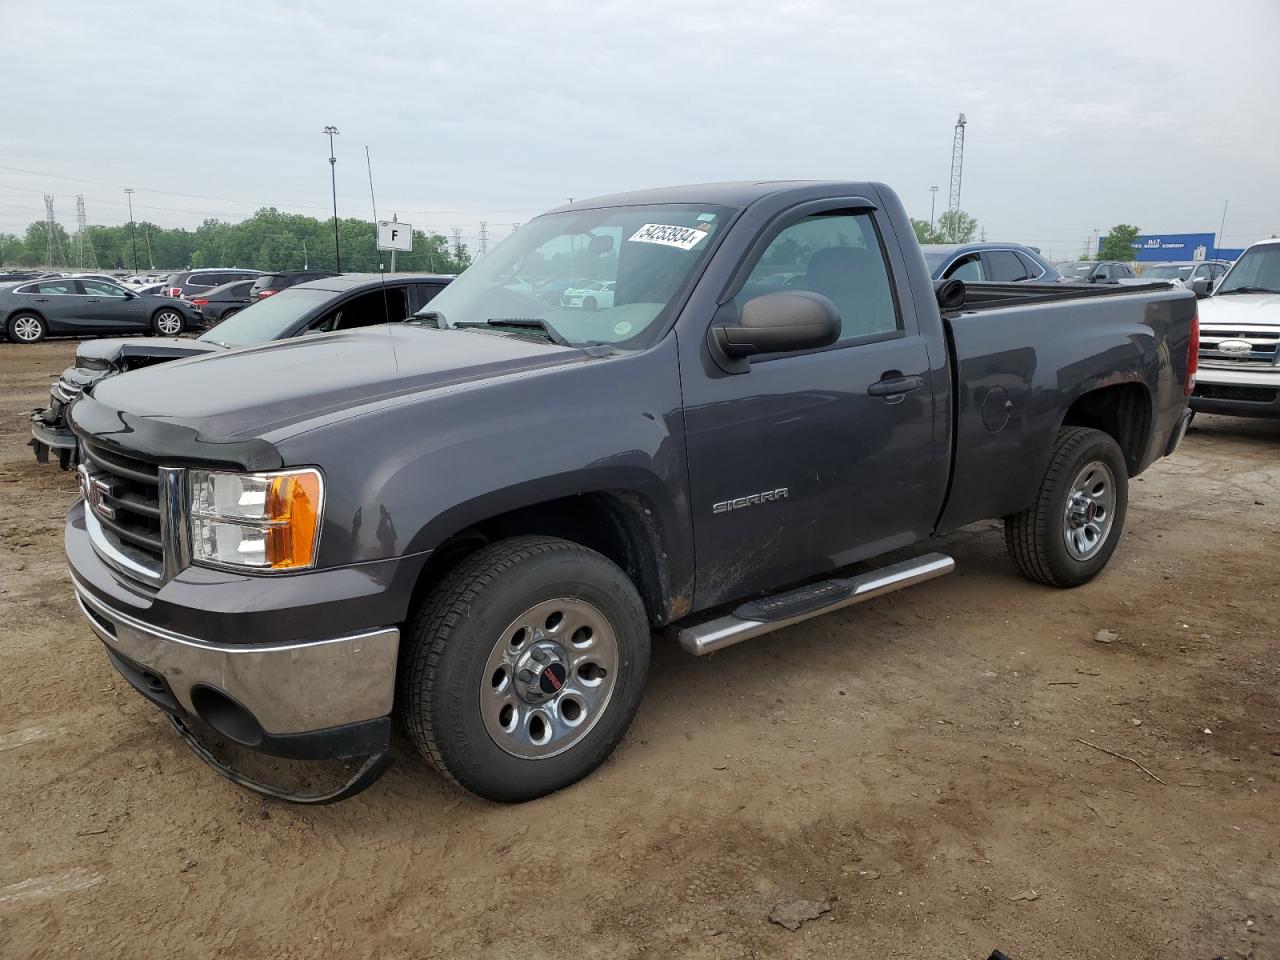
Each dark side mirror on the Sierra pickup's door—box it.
[712,291,840,374]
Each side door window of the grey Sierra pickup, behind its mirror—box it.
[737,212,901,340]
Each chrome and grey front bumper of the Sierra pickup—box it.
[65,500,413,759]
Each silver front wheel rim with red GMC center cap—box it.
[479,596,618,760]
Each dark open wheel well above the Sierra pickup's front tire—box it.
[410,490,689,626]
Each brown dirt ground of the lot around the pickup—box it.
[0,342,1280,960]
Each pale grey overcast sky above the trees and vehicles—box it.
[0,0,1280,257]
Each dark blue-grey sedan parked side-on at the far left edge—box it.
[0,276,204,343]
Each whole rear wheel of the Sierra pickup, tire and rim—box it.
[1005,426,1129,586]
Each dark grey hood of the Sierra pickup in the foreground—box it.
[93,324,589,442]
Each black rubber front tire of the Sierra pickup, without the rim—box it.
[399,536,649,803]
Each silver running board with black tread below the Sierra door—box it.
[677,553,956,657]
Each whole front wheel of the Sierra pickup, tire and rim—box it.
[399,536,649,803]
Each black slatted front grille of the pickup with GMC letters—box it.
[81,436,164,576]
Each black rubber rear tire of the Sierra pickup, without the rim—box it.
[1005,426,1129,588]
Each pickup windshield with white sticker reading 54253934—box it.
[409,204,731,347]
